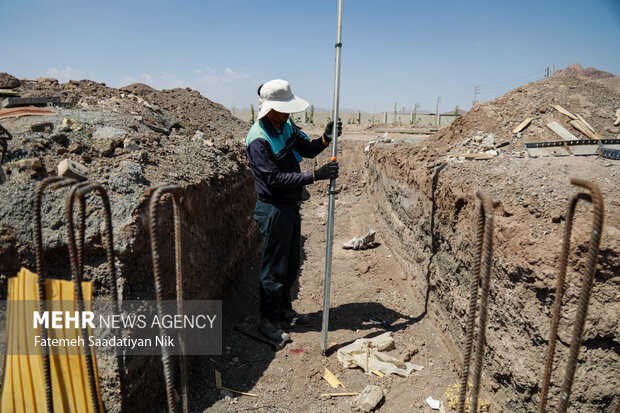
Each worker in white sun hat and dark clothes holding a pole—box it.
[246,79,342,343]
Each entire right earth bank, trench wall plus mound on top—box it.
[369,72,620,412]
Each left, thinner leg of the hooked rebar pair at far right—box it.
[539,192,592,413]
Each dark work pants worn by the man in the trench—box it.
[254,200,301,321]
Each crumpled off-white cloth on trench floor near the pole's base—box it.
[337,331,424,377]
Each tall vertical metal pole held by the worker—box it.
[321,0,342,355]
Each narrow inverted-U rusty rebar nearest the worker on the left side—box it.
[150,184,189,413]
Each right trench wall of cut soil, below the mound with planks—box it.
[368,145,620,412]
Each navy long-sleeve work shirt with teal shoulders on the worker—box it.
[246,118,326,204]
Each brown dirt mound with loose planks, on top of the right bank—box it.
[427,76,620,157]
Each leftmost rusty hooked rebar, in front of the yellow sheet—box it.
[33,176,75,413]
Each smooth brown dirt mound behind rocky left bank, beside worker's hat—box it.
[121,83,248,138]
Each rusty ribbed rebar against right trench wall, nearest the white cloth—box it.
[458,190,493,413]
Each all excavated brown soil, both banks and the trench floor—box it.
[0,72,620,413]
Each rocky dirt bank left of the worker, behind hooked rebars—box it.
[0,74,259,412]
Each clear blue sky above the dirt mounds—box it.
[0,0,620,112]
